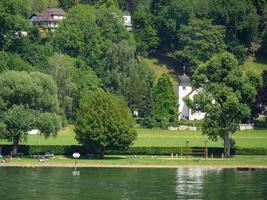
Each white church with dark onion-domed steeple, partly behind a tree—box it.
[176,73,205,120]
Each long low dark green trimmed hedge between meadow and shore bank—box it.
[0,145,267,156]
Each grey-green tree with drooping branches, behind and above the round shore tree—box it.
[99,40,153,113]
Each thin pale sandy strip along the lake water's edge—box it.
[0,163,267,169]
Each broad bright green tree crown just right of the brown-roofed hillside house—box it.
[52,5,132,68]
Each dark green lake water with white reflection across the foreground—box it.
[0,167,267,200]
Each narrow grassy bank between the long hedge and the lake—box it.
[0,156,267,167]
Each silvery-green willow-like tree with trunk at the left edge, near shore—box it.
[0,71,61,154]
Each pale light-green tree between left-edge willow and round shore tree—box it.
[45,53,99,122]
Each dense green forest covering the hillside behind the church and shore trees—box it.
[0,0,267,130]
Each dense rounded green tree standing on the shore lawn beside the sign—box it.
[75,91,136,157]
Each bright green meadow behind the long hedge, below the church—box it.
[0,126,267,147]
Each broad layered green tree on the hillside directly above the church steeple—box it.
[175,19,226,72]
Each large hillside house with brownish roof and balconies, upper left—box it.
[29,8,65,29]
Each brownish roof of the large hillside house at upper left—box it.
[30,8,65,22]
